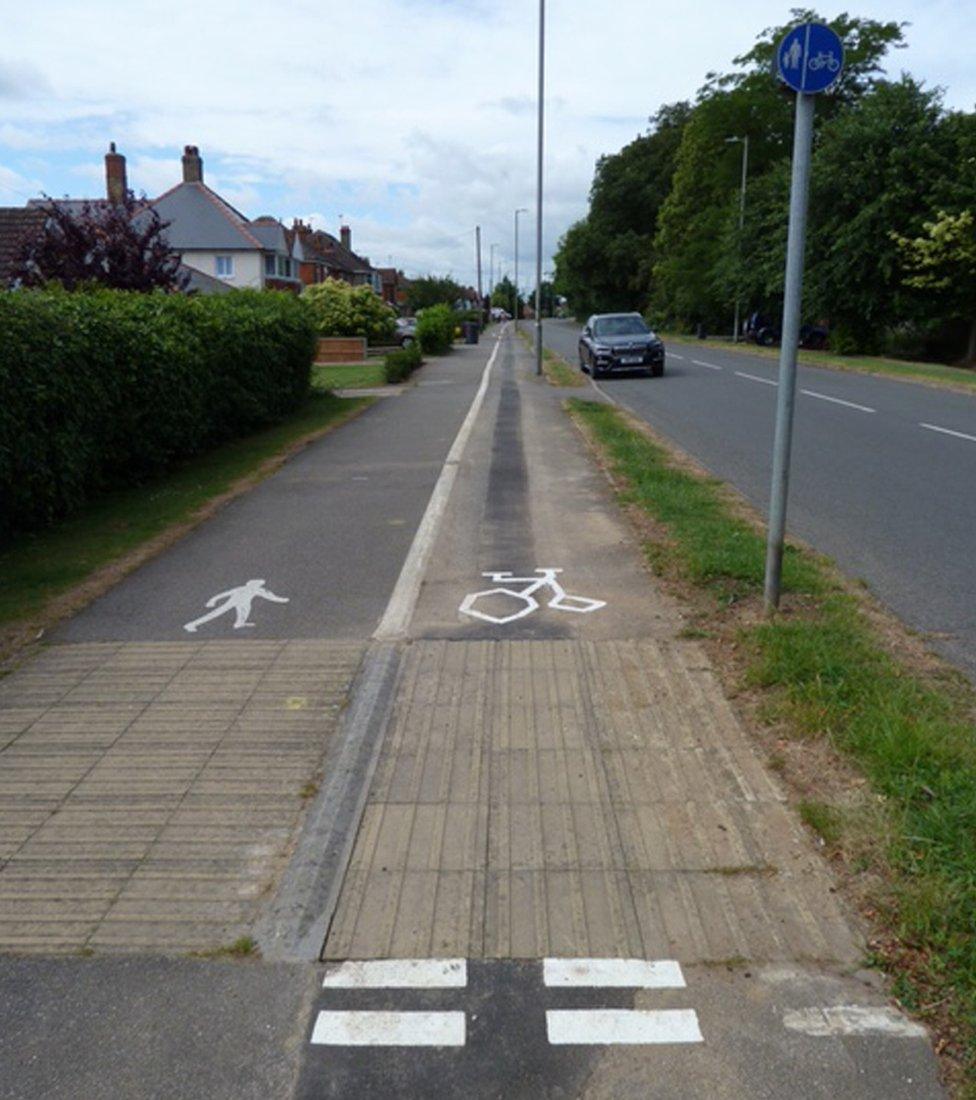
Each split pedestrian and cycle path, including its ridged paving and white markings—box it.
[0,326,943,1100]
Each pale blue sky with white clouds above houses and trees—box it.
[0,0,976,287]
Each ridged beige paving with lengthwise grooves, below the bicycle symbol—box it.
[325,639,858,963]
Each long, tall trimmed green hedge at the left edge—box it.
[0,289,316,538]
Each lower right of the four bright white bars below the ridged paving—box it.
[546,1009,703,1046]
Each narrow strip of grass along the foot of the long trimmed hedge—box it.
[0,391,369,625]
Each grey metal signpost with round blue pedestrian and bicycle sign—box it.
[764,23,844,615]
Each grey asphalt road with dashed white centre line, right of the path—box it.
[544,321,976,678]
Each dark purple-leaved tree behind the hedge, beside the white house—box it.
[13,191,187,290]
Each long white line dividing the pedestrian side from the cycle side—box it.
[373,327,502,641]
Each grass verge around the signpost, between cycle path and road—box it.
[568,399,976,1098]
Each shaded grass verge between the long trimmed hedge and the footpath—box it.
[0,388,371,658]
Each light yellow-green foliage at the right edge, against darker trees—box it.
[891,210,976,364]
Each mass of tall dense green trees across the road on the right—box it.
[556,9,976,358]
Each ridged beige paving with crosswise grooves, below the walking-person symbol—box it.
[0,641,362,952]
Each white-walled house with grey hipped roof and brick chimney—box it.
[149,145,301,293]
